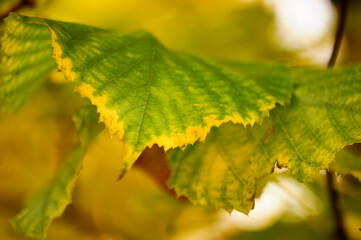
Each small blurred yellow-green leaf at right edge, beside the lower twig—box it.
[331,149,361,181]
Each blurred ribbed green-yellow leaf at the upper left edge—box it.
[0,13,56,113]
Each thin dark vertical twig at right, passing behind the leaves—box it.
[327,0,349,240]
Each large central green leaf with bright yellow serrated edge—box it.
[0,14,291,171]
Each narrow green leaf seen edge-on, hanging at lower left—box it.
[13,106,103,239]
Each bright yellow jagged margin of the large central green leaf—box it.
[27,18,285,172]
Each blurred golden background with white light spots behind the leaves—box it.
[0,0,361,240]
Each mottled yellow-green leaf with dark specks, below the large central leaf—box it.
[168,123,274,213]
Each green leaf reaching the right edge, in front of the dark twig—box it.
[268,65,361,178]
